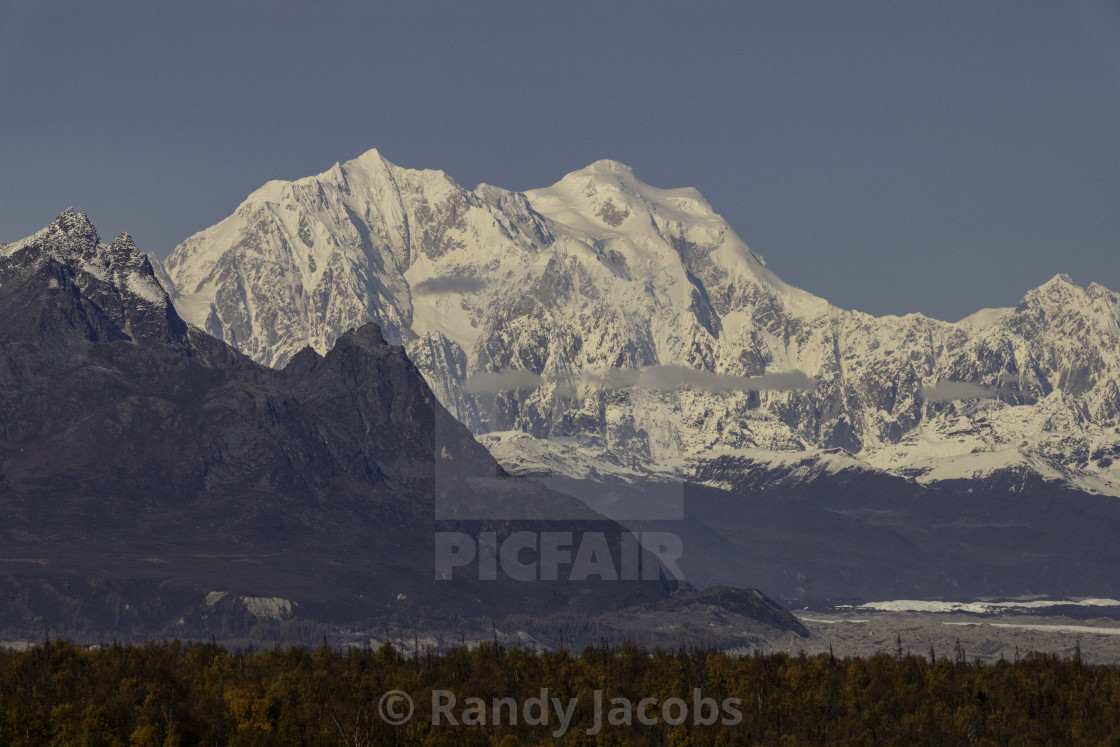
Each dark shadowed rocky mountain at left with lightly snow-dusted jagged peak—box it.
[0,211,800,641]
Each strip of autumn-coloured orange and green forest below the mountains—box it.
[0,641,1120,747]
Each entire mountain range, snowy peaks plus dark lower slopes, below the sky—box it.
[0,151,1120,645]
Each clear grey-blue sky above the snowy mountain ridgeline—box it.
[0,0,1120,320]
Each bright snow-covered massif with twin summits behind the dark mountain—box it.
[157,150,1120,495]
